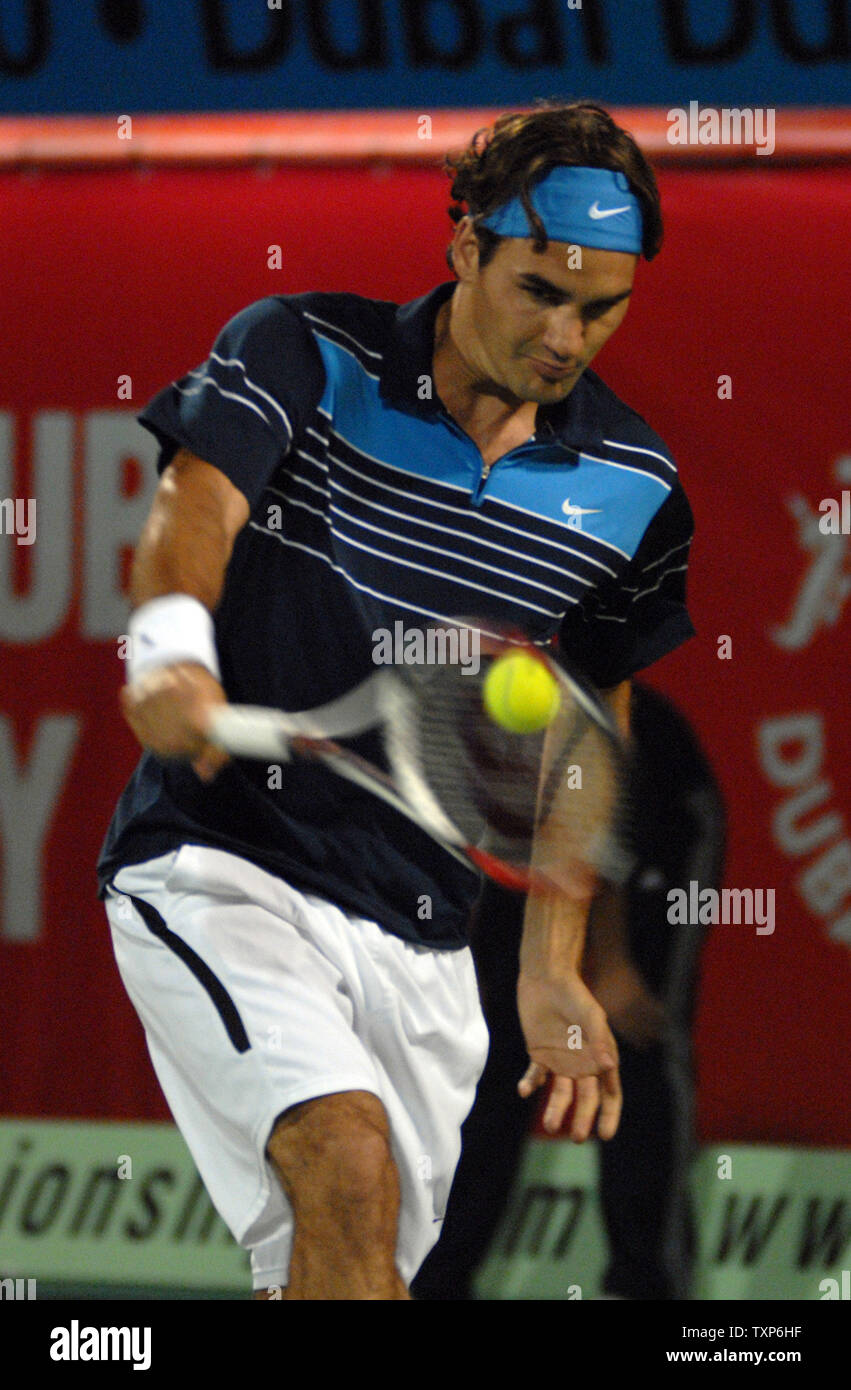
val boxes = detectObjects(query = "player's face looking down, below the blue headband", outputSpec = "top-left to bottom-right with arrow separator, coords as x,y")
453,224 -> 638,404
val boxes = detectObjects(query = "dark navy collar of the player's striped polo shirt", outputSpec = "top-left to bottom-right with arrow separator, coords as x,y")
378,279 -> 603,455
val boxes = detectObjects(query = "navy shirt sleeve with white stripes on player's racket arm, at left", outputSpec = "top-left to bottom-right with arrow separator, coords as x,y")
139,297 -> 324,506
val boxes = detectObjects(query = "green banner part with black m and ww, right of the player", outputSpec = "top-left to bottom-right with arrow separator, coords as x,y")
477,1138 -> 851,1300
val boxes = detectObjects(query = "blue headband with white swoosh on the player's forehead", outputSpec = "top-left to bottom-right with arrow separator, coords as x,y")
481,164 -> 642,254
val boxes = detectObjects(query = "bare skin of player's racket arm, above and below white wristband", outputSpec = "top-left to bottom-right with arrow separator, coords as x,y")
121,449 -> 250,781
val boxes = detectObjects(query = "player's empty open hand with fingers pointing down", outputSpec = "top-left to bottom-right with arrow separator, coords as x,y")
517,970 -> 622,1144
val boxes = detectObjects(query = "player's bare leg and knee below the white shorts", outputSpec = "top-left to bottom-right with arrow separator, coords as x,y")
261,1091 -> 409,1300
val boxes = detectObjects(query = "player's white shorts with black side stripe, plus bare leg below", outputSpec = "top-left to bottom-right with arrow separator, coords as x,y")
107,847 -> 487,1298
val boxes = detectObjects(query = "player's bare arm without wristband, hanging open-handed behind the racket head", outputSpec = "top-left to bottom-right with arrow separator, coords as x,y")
517,681 -> 630,1143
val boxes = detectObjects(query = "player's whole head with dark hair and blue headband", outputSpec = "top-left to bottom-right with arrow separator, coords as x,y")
446,101 -> 662,404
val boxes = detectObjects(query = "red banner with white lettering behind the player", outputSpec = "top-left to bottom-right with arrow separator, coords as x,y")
0,159 -> 851,1144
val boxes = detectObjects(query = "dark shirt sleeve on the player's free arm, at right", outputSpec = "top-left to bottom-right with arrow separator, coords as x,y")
559,481 -> 694,689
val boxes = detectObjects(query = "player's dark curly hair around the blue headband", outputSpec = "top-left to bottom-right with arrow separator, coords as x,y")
444,100 -> 662,270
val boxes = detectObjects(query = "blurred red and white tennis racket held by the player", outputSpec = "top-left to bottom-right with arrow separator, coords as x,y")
209,621 -> 631,897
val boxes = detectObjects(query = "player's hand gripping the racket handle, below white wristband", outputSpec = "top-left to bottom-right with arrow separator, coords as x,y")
121,662 -> 228,781
